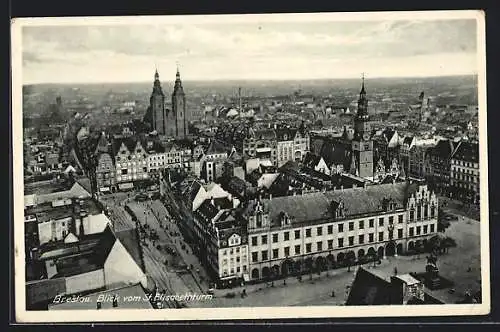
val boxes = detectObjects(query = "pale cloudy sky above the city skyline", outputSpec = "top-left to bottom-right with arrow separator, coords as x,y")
22,14 -> 478,84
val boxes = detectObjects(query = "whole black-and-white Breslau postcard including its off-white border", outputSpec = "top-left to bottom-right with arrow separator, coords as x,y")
11,10 -> 490,322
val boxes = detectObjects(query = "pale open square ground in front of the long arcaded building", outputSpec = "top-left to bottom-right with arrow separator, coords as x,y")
188,217 -> 481,307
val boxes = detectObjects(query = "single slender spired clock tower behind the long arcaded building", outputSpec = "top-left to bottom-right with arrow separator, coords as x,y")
351,76 -> 373,180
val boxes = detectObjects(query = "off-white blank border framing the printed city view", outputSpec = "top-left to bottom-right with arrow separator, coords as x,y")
11,10 -> 491,323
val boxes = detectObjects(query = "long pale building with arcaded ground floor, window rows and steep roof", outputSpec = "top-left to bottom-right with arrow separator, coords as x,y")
243,182 -> 437,280
